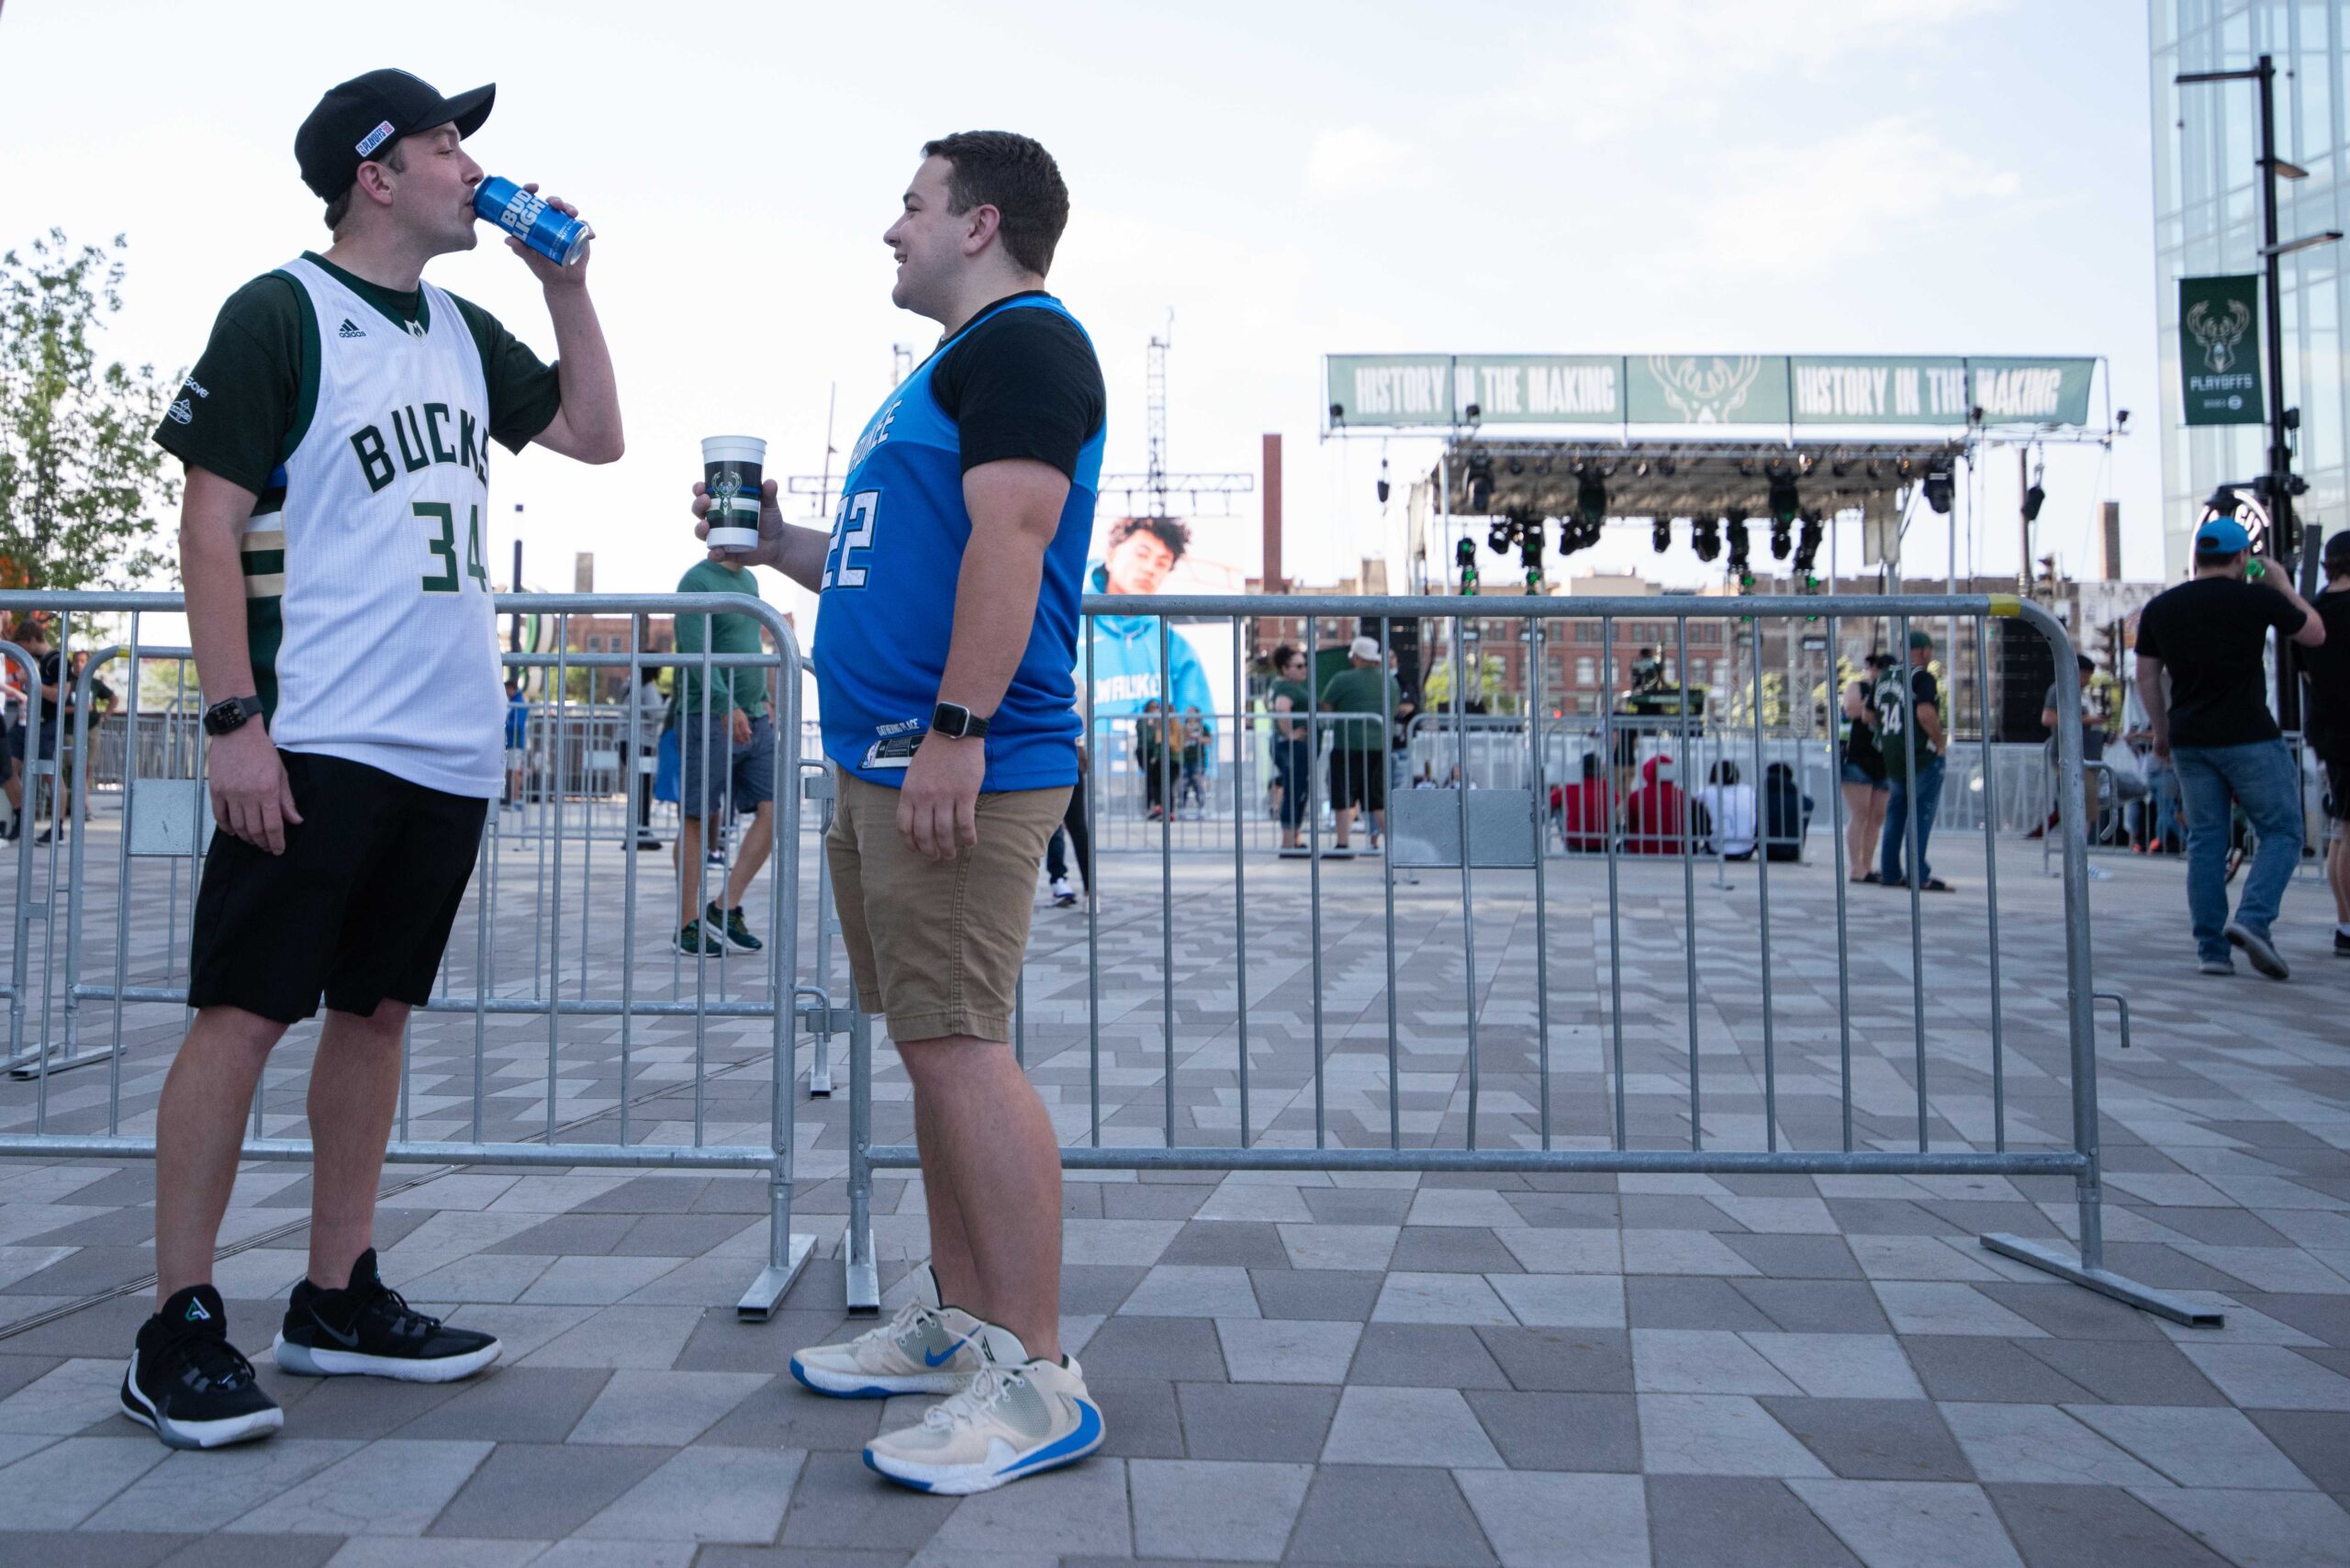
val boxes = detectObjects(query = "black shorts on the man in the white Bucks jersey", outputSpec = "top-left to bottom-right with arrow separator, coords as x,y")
188,752 -> 488,1023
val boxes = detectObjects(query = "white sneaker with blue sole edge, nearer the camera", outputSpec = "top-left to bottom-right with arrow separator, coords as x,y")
865,1324 -> 1102,1497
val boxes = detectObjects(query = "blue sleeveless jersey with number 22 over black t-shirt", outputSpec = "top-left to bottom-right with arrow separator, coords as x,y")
815,294 -> 1104,792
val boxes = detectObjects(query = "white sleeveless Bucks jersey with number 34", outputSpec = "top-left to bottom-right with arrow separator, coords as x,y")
240,259 -> 505,797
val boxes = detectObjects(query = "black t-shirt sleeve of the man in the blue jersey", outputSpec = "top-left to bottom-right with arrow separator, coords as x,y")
931,308 -> 1109,479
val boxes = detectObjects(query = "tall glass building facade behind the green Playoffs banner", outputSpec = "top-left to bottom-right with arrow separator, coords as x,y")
2148,0 -> 2350,580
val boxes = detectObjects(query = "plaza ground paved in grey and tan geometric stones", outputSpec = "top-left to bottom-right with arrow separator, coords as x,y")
0,823 -> 2350,1568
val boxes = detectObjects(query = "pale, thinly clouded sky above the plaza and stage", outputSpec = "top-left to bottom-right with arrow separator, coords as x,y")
0,0 -> 2160,625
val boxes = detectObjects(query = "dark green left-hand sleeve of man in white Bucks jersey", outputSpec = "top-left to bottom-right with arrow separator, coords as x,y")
155,273 -> 318,494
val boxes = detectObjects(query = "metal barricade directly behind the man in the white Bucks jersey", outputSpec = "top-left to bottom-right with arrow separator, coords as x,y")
0,592 -> 813,1319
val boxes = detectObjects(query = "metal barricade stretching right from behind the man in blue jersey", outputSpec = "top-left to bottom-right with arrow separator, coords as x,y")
846,595 -> 2219,1324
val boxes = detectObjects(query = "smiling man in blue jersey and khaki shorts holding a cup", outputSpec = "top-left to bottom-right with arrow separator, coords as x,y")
696,131 -> 1107,1495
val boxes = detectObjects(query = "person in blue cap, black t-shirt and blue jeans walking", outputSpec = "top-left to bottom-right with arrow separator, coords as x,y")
2139,517 -> 2326,980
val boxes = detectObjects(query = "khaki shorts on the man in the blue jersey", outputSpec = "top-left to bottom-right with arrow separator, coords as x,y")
825,768 -> 1069,1041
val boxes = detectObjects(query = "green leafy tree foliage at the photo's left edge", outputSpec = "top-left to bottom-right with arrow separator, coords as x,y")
0,228 -> 179,590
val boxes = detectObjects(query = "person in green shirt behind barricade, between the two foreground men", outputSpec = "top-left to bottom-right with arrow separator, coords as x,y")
677,559 -> 776,955
